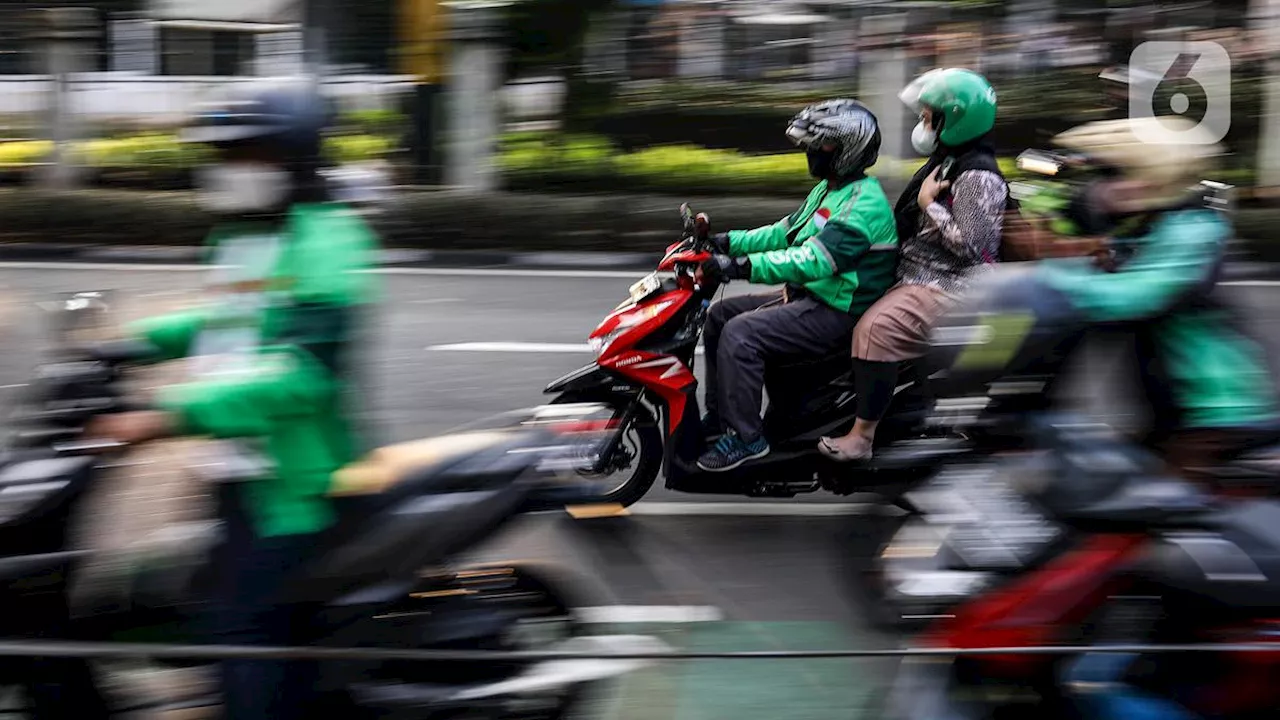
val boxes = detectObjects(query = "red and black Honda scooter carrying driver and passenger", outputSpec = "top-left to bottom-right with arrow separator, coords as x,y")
544,205 -> 966,505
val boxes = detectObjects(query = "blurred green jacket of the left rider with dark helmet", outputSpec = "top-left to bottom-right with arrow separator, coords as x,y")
132,204 -> 378,536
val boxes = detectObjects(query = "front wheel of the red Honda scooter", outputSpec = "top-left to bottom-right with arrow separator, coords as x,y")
552,393 -> 663,507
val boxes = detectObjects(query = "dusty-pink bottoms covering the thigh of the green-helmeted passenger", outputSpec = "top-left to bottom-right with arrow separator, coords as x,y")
854,284 -> 955,363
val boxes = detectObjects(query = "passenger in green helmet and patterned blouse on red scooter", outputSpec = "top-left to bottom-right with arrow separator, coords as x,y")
818,68 -> 1009,461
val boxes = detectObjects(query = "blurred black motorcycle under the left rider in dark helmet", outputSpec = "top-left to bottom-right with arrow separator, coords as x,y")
0,288 -> 664,719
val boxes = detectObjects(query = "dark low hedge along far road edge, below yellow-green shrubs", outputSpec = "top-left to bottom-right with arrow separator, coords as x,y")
0,183 -> 1280,259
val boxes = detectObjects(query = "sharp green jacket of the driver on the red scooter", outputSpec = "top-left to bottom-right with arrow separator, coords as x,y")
728,178 -> 897,315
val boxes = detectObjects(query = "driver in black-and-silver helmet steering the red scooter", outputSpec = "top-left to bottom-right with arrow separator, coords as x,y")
698,99 -> 897,471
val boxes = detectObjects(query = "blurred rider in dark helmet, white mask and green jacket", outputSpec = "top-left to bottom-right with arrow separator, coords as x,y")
90,82 -> 376,720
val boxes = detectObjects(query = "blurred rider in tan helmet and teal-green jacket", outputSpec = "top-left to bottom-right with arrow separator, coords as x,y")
1038,118 -> 1280,486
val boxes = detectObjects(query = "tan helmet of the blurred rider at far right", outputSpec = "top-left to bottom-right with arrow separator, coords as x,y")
1053,118 -> 1222,208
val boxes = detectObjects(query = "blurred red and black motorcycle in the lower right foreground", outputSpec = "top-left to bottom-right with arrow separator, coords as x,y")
878,415 -> 1280,720
